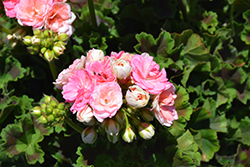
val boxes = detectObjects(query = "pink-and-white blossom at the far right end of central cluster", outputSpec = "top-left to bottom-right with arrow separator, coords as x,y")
152,83 -> 178,126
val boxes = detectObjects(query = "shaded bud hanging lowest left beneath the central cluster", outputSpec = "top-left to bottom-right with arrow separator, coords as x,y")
82,126 -> 97,144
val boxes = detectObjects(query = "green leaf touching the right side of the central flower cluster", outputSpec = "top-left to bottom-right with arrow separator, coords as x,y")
175,86 -> 193,120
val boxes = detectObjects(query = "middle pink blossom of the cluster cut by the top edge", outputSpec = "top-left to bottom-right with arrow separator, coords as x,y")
15,0 -> 53,29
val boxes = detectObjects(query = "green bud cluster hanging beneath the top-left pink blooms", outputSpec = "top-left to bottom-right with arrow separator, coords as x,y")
23,29 -> 68,62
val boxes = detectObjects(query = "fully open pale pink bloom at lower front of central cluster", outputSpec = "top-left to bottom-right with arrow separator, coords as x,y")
90,82 -> 123,122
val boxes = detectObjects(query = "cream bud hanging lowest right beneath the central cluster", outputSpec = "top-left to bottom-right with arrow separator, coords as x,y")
138,122 -> 155,140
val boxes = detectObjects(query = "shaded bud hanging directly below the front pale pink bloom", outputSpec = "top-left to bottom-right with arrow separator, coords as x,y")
104,119 -> 120,136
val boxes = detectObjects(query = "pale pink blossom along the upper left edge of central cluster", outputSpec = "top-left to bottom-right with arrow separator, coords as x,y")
53,56 -> 86,89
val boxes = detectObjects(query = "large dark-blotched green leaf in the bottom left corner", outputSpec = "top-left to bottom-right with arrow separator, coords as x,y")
1,116 -> 53,164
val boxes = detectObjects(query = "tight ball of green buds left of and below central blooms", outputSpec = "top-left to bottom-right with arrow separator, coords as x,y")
31,95 -> 65,126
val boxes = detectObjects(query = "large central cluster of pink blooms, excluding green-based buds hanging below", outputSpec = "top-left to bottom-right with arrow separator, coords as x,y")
54,49 -> 178,126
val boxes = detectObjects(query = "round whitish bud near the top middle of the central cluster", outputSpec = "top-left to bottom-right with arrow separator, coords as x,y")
112,59 -> 132,79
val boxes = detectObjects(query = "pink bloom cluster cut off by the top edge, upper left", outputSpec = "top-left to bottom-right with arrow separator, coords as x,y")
3,0 -> 76,36
